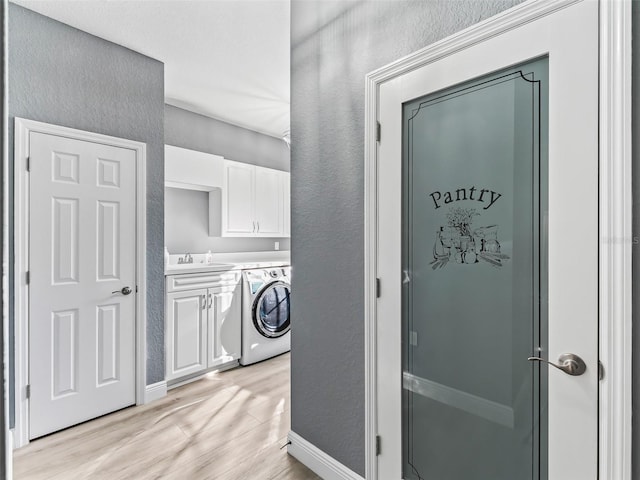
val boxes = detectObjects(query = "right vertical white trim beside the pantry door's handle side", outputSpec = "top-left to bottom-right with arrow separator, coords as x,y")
599,0 -> 634,480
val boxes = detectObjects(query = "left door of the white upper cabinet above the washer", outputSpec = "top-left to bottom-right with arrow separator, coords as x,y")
222,160 -> 257,237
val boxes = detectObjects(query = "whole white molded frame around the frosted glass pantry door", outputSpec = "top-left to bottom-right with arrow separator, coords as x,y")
364,0 -> 633,480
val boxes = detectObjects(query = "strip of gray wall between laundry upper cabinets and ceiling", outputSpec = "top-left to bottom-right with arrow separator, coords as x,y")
164,105 -> 290,172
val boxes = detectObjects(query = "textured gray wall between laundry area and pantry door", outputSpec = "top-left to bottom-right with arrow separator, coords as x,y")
291,0 -> 520,475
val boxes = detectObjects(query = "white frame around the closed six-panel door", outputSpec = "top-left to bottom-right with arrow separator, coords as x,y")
13,118 -> 147,448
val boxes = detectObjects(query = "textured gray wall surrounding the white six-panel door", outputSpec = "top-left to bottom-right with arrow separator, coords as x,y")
8,4 -> 164,424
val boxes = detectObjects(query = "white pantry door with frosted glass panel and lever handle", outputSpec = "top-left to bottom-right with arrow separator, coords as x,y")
375,1 -> 598,480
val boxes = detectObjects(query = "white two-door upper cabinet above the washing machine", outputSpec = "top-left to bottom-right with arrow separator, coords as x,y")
222,159 -> 288,237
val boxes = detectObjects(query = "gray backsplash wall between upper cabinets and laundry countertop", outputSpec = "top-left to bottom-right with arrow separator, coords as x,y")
164,188 -> 291,254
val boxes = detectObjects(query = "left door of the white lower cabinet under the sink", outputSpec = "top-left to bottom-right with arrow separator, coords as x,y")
165,289 -> 208,380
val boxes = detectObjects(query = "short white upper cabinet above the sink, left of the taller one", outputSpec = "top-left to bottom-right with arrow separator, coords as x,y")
164,145 -> 224,192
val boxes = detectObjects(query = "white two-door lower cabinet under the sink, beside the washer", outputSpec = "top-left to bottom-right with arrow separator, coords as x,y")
165,272 -> 241,383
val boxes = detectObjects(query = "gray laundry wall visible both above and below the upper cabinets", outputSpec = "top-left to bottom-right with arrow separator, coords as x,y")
164,105 -> 290,253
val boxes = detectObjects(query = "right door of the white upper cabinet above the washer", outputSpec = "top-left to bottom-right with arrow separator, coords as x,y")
255,167 -> 283,237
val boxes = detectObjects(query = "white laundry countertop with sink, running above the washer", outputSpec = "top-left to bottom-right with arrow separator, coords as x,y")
164,251 -> 291,275
